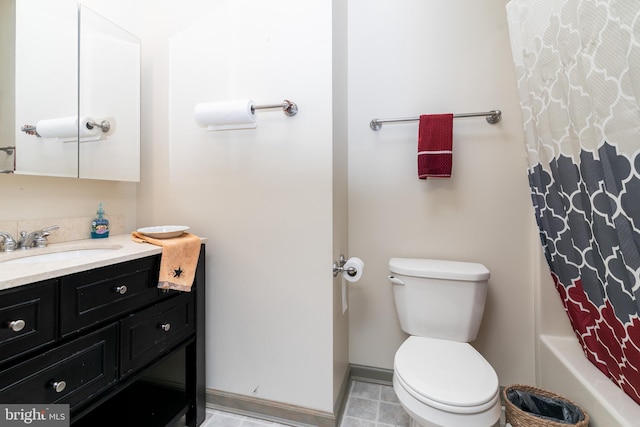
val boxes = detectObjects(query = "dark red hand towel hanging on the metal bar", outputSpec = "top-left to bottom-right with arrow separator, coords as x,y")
418,114 -> 453,179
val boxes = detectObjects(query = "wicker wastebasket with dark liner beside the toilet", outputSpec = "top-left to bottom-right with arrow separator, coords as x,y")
502,384 -> 589,427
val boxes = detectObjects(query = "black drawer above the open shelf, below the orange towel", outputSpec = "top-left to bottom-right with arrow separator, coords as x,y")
120,293 -> 195,375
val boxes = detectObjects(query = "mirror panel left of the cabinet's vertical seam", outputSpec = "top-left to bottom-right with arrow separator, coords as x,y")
13,0 -> 78,177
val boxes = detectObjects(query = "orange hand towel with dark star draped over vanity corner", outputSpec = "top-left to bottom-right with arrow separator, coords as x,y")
131,231 -> 201,292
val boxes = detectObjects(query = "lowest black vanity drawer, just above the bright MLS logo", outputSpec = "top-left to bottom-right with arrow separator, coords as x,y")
0,324 -> 118,408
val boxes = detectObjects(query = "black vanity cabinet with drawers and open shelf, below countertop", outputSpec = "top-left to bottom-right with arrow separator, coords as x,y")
0,245 -> 205,427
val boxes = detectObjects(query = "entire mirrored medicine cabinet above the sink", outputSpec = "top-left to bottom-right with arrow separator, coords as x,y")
0,0 -> 140,181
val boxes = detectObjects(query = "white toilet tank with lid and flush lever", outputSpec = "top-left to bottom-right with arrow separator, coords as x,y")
389,258 -> 490,342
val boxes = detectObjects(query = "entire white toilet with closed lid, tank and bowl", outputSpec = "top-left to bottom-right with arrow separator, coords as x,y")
389,258 -> 501,427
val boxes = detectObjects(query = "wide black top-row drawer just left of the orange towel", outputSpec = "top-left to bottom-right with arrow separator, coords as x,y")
60,257 -> 159,336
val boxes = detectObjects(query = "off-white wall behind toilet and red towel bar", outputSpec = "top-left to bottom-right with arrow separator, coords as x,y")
349,0 -> 535,385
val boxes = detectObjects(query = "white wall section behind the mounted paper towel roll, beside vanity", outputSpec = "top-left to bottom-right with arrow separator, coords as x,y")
139,0 -> 346,412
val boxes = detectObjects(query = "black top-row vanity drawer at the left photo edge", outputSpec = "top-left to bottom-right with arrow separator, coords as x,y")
0,280 -> 57,362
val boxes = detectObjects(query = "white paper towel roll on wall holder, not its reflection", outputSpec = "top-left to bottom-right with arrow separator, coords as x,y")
193,99 -> 256,130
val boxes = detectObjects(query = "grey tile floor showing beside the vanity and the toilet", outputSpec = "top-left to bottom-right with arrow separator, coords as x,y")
202,381 -> 409,427
